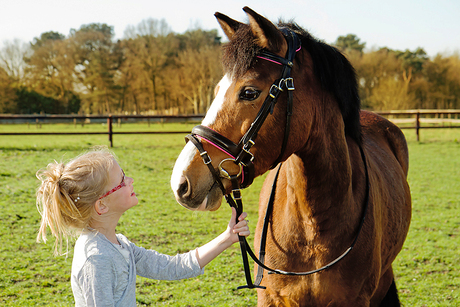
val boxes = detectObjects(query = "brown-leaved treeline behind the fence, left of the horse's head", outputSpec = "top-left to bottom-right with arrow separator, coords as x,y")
0,19 -> 222,114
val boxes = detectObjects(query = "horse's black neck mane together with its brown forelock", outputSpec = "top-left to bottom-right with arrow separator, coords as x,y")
222,22 -> 361,143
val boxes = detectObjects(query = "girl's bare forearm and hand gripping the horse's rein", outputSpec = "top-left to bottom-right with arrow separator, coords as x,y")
196,208 -> 250,268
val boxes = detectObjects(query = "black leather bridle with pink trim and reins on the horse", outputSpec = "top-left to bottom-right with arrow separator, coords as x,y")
186,28 -> 369,289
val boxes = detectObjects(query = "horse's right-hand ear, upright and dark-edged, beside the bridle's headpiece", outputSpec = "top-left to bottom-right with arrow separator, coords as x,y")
243,6 -> 287,56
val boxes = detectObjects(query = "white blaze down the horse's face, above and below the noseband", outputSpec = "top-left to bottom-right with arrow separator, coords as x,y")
171,75 -> 231,210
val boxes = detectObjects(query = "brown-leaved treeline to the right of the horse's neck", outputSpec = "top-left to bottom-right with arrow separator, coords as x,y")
335,34 -> 460,110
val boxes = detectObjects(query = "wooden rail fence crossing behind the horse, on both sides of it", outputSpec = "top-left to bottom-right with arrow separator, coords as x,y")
0,110 -> 460,147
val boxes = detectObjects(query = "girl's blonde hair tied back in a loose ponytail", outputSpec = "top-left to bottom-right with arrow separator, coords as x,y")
36,148 -> 115,255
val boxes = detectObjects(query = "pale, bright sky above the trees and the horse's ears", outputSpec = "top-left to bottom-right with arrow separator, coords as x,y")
0,0 -> 460,57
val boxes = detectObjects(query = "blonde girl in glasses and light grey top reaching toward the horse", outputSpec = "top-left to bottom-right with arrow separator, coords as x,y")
37,149 -> 249,306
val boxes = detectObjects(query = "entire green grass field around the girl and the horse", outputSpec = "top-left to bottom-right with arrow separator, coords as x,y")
0,124 -> 460,306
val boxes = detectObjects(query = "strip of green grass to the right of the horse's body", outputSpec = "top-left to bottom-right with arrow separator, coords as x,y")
395,129 -> 460,306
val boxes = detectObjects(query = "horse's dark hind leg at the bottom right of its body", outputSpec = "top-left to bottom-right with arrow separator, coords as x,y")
370,267 -> 401,307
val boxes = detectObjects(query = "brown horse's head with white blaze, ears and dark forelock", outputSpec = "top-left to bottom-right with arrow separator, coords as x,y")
171,7 -> 362,210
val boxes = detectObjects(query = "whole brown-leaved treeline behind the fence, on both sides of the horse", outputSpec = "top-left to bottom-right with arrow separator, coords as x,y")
0,19 -> 460,114
